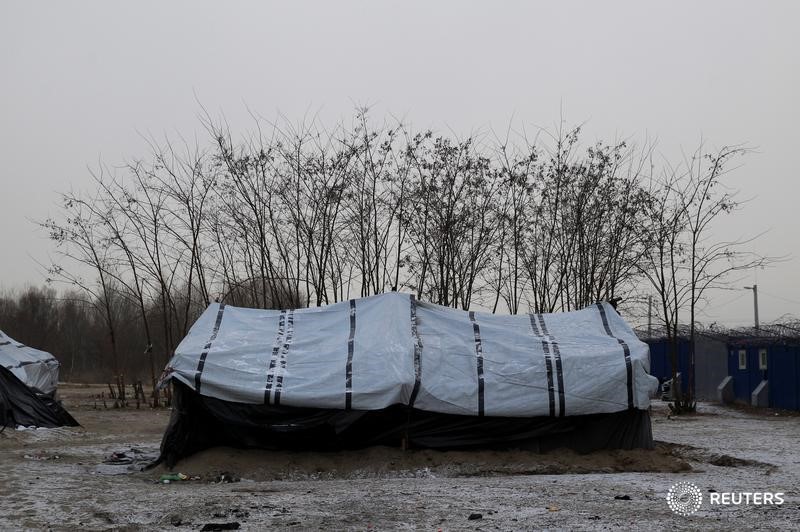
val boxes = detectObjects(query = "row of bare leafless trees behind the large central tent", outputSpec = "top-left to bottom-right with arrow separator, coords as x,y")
3,109 -> 763,408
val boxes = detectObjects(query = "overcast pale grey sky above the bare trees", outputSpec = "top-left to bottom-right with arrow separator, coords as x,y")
0,0 -> 800,325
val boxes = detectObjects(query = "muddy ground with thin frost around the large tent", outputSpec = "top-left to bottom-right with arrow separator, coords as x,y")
0,385 -> 800,531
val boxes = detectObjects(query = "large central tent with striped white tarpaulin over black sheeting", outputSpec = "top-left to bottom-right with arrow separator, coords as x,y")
155,292 -> 658,466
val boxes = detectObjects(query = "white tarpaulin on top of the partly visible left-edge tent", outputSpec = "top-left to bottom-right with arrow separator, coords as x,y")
0,331 -> 59,394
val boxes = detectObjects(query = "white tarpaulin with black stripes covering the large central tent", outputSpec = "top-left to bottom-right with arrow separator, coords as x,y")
165,293 -> 658,417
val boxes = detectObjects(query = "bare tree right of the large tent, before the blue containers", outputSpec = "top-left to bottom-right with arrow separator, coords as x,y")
643,144 -> 773,413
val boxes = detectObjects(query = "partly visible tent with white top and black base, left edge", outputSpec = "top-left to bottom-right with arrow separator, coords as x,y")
0,331 -> 78,427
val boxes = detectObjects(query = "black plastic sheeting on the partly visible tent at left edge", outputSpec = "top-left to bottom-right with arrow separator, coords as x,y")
0,366 -> 79,428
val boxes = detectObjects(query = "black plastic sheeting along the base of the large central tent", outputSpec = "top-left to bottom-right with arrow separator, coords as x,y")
158,381 -> 653,467
